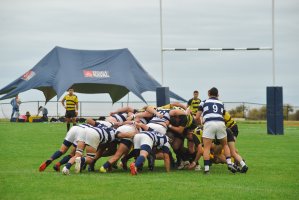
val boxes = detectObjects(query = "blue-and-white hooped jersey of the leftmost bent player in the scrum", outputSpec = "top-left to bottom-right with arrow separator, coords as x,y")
79,124 -> 116,144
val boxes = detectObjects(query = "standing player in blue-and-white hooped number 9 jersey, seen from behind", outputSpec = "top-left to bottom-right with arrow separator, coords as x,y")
196,87 -> 237,174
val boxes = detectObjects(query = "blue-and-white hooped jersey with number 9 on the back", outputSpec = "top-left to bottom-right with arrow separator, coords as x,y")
198,97 -> 224,123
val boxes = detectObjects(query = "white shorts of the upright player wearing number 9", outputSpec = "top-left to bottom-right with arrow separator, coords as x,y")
202,121 -> 227,139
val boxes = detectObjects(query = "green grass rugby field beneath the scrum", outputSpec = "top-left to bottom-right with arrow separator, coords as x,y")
0,122 -> 299,200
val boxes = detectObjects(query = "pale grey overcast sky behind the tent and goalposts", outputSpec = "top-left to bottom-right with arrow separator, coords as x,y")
0,0 -> 299,106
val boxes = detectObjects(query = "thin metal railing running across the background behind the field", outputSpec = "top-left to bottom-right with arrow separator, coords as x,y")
0,101 -> 299,120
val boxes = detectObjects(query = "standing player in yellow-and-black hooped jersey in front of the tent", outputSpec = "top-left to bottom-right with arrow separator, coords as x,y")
61,88 -> 78,131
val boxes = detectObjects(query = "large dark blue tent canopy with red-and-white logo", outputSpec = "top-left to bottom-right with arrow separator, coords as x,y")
0,47 -> 185,103
